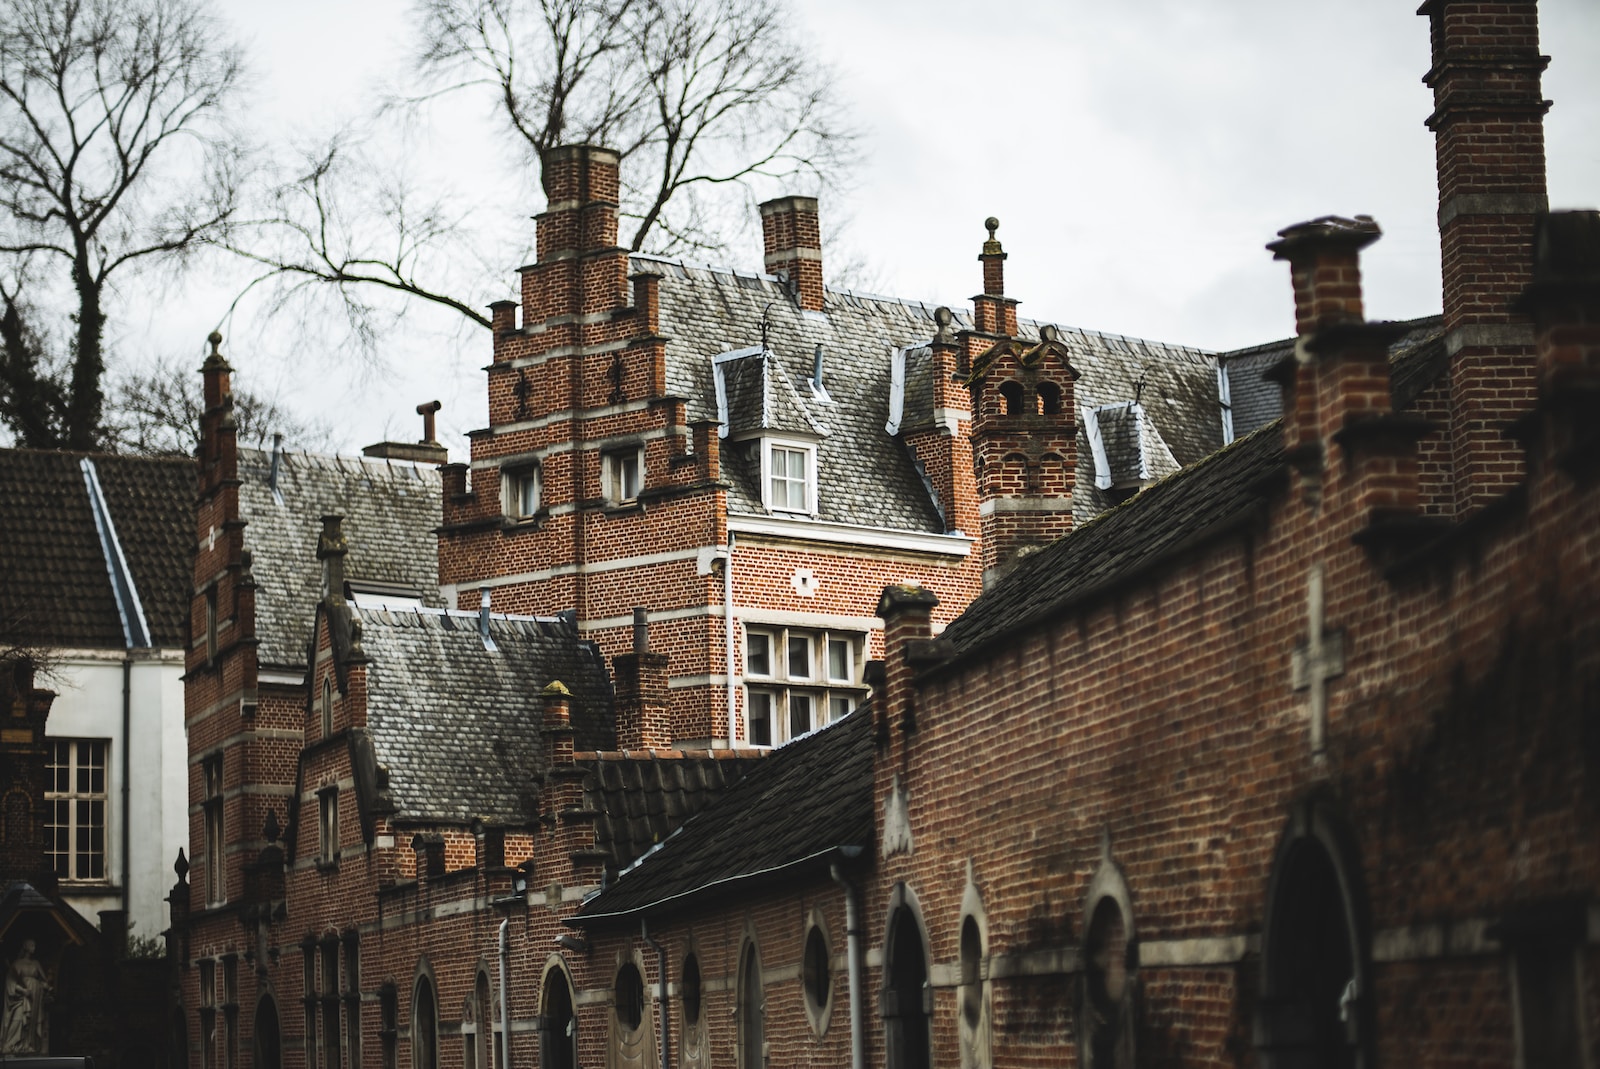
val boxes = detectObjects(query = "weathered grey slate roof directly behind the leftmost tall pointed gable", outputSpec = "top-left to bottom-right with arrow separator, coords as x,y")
238,450 -> 443,667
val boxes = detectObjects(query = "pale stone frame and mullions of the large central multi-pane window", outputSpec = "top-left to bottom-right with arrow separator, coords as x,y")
739,623 -> 867,747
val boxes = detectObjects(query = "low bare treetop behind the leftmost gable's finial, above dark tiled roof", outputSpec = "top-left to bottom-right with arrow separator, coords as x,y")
106,358 -> 333,456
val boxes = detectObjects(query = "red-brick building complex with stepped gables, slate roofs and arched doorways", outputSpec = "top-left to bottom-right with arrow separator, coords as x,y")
174,0 -> 1600,1069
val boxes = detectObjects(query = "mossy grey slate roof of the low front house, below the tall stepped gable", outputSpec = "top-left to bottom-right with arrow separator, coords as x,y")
352,604 -> 616,824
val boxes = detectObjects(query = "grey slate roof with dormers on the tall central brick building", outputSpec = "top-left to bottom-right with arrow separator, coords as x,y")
632,254 -> 1222,535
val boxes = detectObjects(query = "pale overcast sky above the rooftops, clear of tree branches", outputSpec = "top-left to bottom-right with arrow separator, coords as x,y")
156,0 -> 1600,459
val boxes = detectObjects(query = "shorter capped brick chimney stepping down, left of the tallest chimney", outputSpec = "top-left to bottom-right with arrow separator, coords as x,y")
1267,216 -> 1432,555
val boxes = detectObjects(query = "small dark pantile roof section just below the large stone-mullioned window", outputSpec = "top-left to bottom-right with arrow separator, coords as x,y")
578,751 -> 766,874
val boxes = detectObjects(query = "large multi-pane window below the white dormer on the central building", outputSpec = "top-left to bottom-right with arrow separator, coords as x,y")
744,626 -> 866,746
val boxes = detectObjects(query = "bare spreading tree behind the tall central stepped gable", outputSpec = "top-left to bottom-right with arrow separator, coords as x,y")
222,0 -> 854,349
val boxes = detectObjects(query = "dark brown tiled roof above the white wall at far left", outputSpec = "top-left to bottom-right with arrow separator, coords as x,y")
0,450 -> 195,650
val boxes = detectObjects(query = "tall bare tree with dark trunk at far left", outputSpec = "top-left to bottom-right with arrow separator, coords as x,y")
0,0 -> 240,450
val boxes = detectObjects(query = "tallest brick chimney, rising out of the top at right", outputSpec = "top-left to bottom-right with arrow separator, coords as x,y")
1418,0 -> 1549,515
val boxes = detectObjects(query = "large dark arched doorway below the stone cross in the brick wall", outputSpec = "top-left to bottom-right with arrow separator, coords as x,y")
1258,807 -> 1371,1069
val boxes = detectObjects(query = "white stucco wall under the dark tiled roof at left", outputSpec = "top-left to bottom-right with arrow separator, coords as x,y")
40,650 -> 189,938
